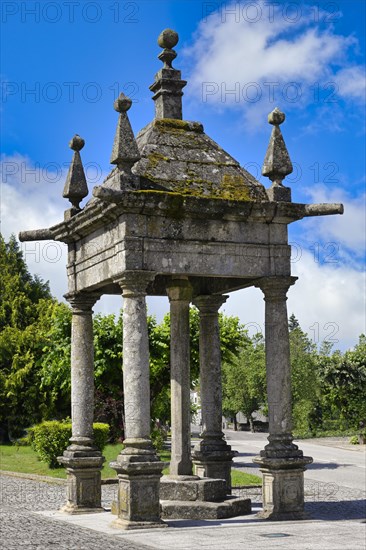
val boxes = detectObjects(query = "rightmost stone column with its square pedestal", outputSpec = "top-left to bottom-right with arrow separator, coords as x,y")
253,277 -> 312,520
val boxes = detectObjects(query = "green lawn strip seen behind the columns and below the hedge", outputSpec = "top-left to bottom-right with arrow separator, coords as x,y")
0,443 -> 262,487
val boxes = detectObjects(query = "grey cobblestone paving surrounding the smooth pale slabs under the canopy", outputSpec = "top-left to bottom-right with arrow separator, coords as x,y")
0,475 -> 366,550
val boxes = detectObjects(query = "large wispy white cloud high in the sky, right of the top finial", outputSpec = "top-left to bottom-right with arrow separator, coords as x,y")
183,0 -> 365,122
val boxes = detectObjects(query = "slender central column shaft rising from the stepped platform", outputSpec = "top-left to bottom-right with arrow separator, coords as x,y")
167,279 -> 192,476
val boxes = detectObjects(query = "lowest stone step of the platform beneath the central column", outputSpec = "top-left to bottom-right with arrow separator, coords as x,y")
160,497 -> 252,519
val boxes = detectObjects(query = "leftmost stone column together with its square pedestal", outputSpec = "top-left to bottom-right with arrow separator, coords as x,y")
58,293 -> 104,514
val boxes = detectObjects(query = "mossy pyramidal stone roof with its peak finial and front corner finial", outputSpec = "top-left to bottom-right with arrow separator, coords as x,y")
96,29 -> 268,205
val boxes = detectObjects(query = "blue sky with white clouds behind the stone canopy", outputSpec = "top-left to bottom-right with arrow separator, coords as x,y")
1,0 -> 366,348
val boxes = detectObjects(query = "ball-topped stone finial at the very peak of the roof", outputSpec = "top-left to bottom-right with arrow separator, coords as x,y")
150,29 -> 187,120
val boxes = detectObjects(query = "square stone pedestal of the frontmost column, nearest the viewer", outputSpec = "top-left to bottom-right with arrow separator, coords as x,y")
110,441 -> 167,529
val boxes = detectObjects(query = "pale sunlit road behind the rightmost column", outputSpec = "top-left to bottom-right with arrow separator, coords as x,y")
225,430 -> 366,491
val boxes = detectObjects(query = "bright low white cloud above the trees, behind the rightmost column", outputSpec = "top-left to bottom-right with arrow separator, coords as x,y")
222,251 -> 366,350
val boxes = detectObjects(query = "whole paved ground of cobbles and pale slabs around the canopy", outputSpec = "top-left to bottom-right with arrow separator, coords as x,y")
0,436 -> 366,550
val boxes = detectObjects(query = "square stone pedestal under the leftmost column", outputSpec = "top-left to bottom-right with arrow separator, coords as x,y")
58,450 -> 104,514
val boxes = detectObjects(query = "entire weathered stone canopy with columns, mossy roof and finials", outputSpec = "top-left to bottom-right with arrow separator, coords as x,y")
20,29 -> 343,528
